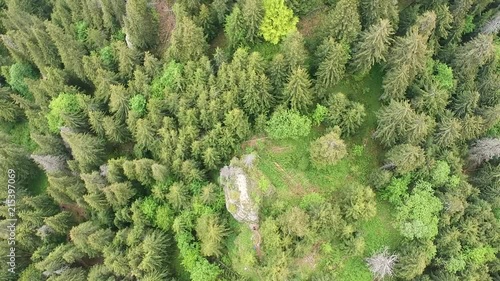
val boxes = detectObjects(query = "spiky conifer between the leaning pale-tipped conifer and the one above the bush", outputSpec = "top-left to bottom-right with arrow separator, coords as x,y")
316,37 -> 349,88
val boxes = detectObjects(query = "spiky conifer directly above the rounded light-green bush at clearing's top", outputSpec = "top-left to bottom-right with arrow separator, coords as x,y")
283,67 -> 314,112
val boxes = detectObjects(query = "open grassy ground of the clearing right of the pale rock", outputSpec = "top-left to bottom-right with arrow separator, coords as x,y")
234,65 -> 401,281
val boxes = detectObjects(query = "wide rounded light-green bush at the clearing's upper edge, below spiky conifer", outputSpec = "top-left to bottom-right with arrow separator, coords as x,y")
265,107 -> 311,139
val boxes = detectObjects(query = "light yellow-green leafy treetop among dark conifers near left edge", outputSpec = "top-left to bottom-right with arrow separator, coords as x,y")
47,93 -> 82,132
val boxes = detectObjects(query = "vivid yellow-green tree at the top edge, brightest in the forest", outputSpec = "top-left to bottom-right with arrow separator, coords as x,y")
260,0 -> 299,44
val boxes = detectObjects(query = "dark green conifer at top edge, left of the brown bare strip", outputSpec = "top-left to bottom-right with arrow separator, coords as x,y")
124,0 -> 158,50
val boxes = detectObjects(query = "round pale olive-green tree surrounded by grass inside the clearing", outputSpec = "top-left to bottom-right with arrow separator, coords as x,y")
310,132 -> 347,168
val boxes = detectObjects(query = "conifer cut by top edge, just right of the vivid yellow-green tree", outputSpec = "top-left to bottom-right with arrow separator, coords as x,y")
325,0 -> 361,45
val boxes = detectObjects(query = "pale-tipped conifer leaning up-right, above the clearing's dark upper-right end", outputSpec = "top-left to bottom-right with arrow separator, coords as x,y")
352,19 -> 394,76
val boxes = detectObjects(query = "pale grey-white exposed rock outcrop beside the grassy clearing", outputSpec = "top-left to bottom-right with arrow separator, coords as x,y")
220,155 -> 259,224
